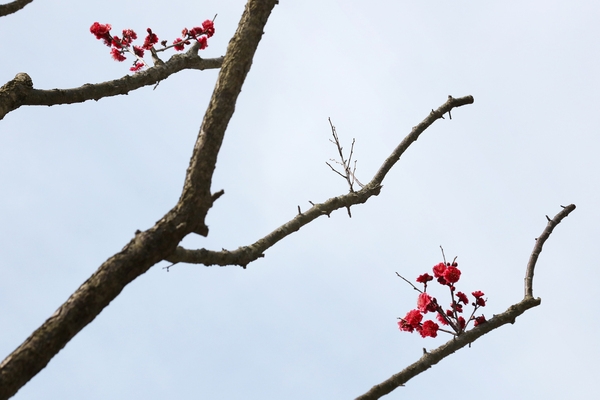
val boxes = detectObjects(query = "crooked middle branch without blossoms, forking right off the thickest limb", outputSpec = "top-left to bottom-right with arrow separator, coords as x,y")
166,96 -> 474,267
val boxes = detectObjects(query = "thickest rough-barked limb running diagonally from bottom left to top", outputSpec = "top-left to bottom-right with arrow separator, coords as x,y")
0,0 -> 277,400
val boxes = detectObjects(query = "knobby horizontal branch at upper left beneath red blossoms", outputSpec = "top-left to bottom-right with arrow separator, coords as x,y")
0,52 -> 223,119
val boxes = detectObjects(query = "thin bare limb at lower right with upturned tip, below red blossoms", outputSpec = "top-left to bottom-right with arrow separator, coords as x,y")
356,204 -> 575,400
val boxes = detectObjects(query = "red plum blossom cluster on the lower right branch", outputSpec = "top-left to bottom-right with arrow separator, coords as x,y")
398,261 -> 487,338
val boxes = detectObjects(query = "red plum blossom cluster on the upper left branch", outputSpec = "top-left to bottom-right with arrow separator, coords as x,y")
90,20 -> 215,72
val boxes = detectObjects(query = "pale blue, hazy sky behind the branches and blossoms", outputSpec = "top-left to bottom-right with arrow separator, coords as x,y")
0,0 -> 600,400
